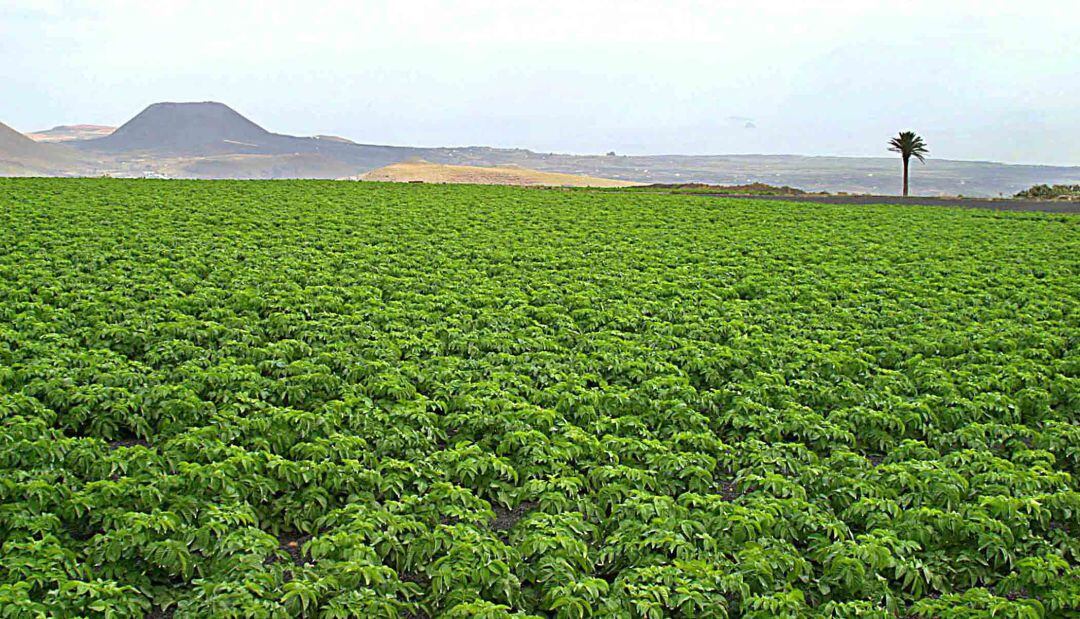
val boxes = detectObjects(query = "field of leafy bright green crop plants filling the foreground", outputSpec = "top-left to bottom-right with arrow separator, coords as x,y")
0,179 -> 1080,619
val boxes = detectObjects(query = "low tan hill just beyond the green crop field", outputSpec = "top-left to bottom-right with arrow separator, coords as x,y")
360,160 -> 635,187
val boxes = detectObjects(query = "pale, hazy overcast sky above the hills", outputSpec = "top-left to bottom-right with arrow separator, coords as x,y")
0,0 -> 1080,165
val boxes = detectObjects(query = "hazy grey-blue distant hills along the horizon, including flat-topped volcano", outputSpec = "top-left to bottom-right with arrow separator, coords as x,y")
0,102 -> 1080,197
